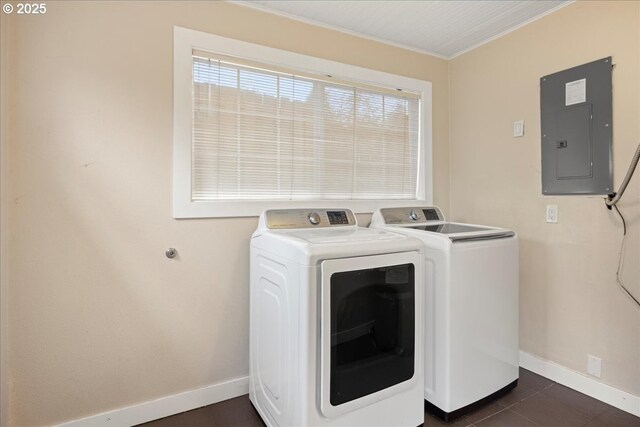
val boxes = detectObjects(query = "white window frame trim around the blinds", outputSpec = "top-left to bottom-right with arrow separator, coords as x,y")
173,26 -> 433,218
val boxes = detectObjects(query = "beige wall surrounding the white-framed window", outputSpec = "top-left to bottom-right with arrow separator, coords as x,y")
2,1 -> 449,426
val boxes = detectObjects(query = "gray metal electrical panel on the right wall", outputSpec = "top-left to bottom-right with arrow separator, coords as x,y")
540,57 -> 613,195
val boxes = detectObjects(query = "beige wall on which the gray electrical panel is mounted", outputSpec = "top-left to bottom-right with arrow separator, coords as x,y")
449,1 -> 640,395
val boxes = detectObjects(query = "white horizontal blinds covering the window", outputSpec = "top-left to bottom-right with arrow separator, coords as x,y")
191,52 -> 420,201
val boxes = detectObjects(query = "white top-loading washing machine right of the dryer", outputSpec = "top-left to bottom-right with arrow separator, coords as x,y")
371,207 -> 519,421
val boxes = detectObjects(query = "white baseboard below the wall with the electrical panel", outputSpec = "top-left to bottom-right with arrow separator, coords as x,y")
520,350 -> 640,417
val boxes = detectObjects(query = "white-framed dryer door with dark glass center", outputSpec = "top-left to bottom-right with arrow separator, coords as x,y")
319,252 -> 422,417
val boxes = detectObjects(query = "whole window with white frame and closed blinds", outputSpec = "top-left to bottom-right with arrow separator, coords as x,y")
174,27 -> 431,218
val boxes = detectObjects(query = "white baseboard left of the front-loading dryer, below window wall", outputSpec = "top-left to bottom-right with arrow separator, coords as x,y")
58,377 -> 249,427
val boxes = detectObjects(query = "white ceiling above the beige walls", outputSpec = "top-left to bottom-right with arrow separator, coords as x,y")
235,0 -> 572,59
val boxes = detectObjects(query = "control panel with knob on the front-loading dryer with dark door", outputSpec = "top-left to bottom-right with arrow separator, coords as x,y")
264,209 -> 358,229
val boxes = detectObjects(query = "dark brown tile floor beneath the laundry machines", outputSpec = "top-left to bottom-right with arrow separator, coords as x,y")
141,368 -> 640,427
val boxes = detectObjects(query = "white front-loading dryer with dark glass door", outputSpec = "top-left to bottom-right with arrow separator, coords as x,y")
249,209 -> 424,426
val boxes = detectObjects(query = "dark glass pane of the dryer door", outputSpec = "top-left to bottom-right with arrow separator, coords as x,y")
330,264 -> 415,406
